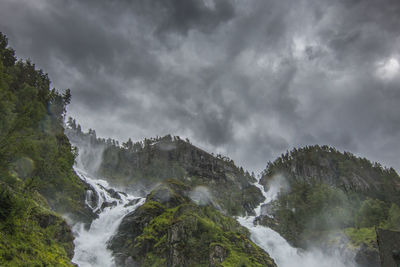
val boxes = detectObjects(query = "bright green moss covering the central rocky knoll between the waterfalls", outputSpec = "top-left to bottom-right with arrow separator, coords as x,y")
131,197 -> 275,266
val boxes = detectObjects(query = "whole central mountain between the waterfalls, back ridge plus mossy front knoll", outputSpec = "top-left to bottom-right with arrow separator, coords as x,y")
66,126 -> 275,266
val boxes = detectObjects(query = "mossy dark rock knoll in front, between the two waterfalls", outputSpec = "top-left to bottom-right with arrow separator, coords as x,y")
109,180 -> 276,266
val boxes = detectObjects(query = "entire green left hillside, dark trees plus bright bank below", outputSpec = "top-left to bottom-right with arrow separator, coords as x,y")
0,33 -> 85,266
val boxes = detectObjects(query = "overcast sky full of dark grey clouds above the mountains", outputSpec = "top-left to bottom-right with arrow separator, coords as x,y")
0,0 -> 400,171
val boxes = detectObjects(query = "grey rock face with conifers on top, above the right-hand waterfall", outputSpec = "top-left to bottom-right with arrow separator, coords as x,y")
260,145 -> 400,204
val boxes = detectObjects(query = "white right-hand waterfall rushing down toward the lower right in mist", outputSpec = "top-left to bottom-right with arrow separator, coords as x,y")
237,177 -> 356,267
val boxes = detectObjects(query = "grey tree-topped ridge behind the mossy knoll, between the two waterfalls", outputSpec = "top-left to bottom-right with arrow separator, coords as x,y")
66,126 -> 264,215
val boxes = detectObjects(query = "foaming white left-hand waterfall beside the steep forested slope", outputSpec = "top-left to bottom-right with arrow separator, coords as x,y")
72,168 -> 144,267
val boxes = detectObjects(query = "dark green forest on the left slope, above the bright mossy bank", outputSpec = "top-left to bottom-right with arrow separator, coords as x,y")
0,35 -> 87,222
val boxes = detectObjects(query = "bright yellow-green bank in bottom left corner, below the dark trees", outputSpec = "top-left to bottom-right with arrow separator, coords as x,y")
0,188 -> 74,266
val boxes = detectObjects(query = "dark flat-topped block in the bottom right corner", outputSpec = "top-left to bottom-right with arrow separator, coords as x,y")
376,228 -> 400,267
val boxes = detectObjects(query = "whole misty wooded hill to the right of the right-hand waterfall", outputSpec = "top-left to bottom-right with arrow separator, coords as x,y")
257,146 -> 400,266
